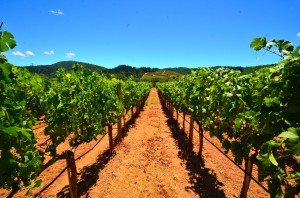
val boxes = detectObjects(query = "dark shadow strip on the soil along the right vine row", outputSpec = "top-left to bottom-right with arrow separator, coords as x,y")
161,96 -> 226,198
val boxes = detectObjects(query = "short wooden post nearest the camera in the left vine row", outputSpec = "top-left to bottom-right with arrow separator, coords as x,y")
66,151 -> 77,198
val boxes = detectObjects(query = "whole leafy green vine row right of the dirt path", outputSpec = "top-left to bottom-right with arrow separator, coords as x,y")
157,38 -> 300,197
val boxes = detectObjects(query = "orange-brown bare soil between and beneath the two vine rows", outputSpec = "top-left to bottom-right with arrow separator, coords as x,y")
0,88 -> 268,198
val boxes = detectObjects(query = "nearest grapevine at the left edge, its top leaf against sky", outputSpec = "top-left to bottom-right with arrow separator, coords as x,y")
0,27 -> 42,191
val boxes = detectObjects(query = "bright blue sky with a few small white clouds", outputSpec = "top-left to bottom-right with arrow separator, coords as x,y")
0,0 -> 300,68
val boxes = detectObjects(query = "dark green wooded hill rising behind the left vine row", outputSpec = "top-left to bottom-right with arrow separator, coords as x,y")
25,61 -> 106,77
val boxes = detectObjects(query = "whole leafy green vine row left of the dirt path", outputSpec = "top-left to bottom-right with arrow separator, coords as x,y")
0,63 -> 151,194
